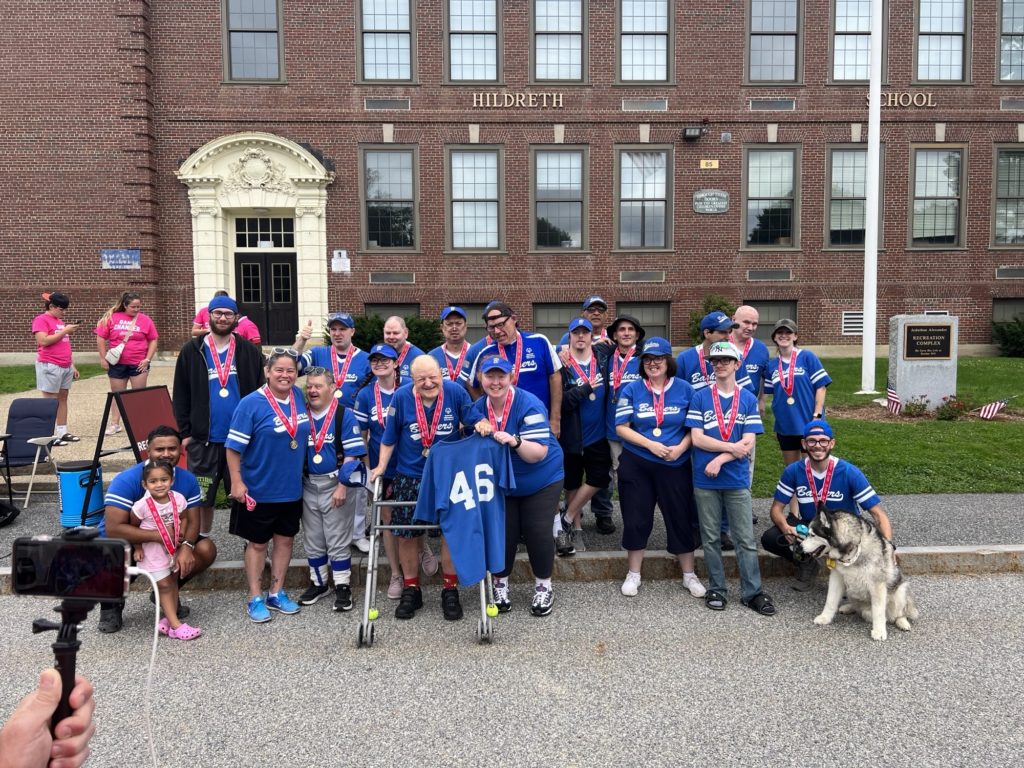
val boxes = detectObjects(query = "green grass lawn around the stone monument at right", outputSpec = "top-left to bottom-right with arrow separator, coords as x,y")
754,357 -> 1024,497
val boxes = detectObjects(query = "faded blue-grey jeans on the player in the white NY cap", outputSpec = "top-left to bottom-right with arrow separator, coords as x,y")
693,487 -> 761,600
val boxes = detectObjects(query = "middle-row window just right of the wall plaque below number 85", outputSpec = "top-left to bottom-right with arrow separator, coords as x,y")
745,148 -> 799,248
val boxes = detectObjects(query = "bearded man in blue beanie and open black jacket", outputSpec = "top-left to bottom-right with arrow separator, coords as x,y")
173,296 -> 263,538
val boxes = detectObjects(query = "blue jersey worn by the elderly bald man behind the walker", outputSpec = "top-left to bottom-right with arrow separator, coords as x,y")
382,381 -> 473,477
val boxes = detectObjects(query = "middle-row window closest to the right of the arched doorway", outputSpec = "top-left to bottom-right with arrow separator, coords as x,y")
362,150 -> 417,250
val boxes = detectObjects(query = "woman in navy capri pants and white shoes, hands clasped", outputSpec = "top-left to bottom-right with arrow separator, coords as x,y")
615,336 -> 705,597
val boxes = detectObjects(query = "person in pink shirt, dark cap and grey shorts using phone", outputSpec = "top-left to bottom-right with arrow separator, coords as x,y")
32,291 -> 81,445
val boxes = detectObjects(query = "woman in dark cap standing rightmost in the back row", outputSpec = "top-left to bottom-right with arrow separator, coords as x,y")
765,318 -> 831,499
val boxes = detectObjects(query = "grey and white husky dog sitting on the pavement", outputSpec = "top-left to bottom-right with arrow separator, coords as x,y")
801,504 -> 918,640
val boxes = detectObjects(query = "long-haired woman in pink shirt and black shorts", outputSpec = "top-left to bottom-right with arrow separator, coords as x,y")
96,291 -> 158,434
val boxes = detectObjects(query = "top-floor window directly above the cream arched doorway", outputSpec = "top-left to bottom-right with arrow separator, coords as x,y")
224,0 -> 283,80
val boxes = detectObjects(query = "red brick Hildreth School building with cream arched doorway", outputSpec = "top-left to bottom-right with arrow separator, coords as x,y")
0,0 -> 1024,351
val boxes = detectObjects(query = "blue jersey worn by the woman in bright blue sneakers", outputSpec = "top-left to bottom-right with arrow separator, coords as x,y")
224,387 -> 309,503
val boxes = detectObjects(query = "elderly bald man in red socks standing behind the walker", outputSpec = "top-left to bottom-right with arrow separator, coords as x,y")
370,354 -> 472,622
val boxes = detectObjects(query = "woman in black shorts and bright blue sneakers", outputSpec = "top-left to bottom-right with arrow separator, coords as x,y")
224,347 -> 309,624
